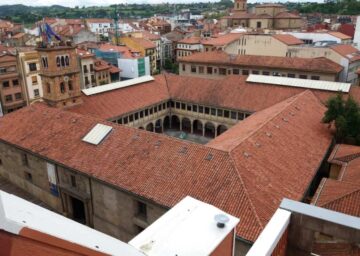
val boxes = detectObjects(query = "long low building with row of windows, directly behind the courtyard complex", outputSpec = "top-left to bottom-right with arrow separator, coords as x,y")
179,51 -> 343,81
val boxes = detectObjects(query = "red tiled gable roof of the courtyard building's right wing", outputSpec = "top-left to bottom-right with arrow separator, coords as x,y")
207,90 -> 332,223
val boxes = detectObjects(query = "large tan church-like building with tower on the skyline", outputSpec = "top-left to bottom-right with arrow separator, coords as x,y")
221,0 -> 303,30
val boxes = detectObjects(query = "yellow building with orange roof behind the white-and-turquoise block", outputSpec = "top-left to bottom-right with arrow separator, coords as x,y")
120,36 -> 158,74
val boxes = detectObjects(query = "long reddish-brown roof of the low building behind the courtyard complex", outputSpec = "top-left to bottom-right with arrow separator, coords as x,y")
179,51 -> 343,74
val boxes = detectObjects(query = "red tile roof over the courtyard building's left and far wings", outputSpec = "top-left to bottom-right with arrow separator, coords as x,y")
69,74 -> 360,119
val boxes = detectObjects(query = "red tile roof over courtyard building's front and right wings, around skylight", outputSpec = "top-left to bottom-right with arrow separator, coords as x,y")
0,90 -> 331,241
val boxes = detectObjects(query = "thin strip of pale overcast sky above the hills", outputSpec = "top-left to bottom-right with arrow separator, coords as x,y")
0,0 -> 323,7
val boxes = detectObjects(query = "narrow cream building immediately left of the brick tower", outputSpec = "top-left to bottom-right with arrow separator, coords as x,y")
17,49 -> 43,105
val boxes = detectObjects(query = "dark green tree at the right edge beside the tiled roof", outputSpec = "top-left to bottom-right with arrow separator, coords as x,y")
323,94 -> 360,145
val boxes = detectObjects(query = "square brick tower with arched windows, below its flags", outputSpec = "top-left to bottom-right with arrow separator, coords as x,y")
37,43 -> 82,108
